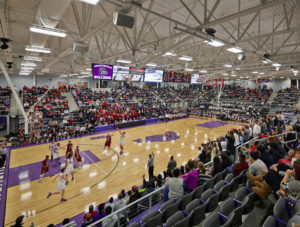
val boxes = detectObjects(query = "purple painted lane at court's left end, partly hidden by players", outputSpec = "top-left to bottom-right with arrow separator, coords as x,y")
8,151 -> 100,187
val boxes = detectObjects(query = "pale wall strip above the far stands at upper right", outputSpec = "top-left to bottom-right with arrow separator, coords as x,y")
240,79 -> 291,92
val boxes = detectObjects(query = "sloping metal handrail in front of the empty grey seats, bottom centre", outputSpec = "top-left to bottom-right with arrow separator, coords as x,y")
85,161 -> 212,227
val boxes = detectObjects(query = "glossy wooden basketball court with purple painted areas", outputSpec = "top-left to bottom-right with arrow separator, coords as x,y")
5,116 -> 242,226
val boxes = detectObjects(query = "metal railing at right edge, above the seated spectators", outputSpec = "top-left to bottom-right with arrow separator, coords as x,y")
235,131 -> 298,160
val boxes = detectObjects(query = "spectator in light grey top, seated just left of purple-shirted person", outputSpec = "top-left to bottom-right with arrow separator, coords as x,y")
164,169 -> 183,199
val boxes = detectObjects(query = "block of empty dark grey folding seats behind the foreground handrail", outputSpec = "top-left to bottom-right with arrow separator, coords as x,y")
129,170 -> 254,227
